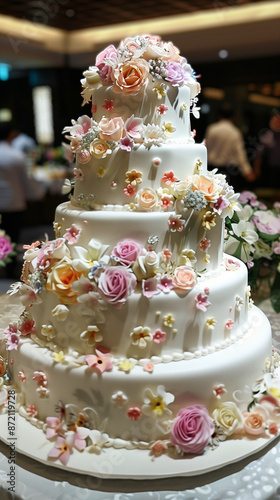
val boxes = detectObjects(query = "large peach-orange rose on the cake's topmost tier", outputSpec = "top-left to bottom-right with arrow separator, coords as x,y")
112,58 -> 150,95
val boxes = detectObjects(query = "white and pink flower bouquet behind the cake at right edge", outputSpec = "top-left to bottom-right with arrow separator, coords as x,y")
225,191 -> 280,312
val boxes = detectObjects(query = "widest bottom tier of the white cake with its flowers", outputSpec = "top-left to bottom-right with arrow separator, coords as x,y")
2,307 -> 279,465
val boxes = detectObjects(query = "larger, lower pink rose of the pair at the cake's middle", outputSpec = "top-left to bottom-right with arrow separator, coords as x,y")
98,266 -> 136,307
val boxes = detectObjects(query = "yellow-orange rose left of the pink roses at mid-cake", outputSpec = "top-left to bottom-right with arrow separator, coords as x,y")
46,257 -> 82,304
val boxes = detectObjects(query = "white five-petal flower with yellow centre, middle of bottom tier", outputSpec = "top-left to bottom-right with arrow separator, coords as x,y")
142,385 -> 175,420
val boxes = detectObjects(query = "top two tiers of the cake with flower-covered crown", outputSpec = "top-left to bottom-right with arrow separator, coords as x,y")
64,36 -> 203,211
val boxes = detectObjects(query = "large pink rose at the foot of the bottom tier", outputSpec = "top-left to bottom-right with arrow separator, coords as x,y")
170,405 -> 215,455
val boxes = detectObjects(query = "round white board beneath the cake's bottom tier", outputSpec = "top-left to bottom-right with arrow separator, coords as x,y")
0,414 -> 277,480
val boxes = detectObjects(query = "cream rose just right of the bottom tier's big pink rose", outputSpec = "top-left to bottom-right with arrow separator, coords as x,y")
212,401 -> 243,436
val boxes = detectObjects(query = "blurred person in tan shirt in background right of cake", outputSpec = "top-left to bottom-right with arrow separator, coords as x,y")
205,104 -> 255,192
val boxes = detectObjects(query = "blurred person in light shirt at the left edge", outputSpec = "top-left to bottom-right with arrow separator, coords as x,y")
0,122 -> 45,278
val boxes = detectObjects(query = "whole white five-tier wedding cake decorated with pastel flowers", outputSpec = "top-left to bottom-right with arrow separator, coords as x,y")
2,36 -> 279,475
